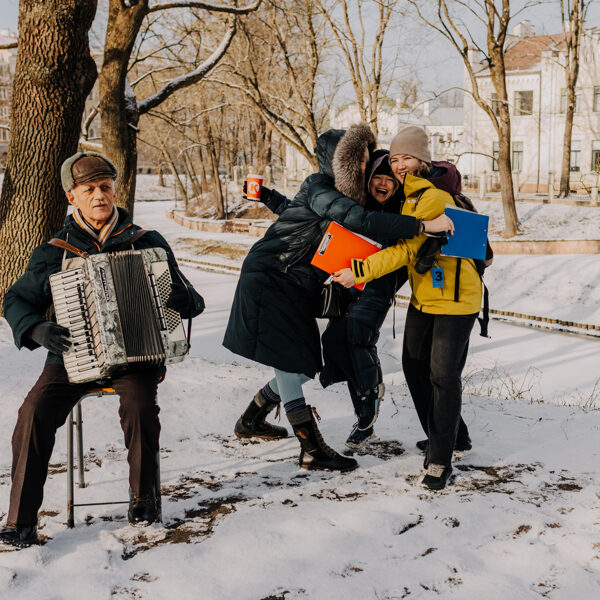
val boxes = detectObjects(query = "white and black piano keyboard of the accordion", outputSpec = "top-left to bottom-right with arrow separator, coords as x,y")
50,268 -> 103,381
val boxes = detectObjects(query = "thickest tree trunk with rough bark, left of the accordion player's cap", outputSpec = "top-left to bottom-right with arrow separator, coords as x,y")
0,0 -> 96,312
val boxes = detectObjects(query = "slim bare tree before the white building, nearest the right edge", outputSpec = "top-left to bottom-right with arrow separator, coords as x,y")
559,0 -> 591,197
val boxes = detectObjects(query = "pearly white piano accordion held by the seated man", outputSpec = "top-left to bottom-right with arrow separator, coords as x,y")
50,248 -> 189,383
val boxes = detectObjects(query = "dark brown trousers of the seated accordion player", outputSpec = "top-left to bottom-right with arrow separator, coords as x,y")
7,365 -> 160,525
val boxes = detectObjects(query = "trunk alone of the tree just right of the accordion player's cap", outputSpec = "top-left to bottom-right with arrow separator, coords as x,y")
98,0 -> 148,215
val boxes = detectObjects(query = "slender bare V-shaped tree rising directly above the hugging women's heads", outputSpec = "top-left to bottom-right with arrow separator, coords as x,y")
315,0 -> 399,136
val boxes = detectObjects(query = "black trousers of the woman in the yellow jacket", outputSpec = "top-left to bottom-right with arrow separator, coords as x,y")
402,304 -> 477,466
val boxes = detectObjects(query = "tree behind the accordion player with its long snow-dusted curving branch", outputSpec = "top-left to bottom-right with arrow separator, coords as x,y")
99,0 -> 261,212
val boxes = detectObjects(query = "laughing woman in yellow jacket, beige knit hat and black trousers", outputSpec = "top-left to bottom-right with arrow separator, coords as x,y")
334,125 -> 482,490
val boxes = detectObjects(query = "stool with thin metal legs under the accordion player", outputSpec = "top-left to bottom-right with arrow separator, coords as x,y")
67,387 -> 162,527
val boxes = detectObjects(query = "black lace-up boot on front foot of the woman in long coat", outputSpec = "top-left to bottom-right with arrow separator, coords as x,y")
288,406 -> 358,471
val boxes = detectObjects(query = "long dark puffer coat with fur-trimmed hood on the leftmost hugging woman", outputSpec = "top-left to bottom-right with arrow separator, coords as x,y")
223,125 -> 419,377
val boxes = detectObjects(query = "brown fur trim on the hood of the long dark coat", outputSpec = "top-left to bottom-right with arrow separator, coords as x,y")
333,123 -> 376,206
